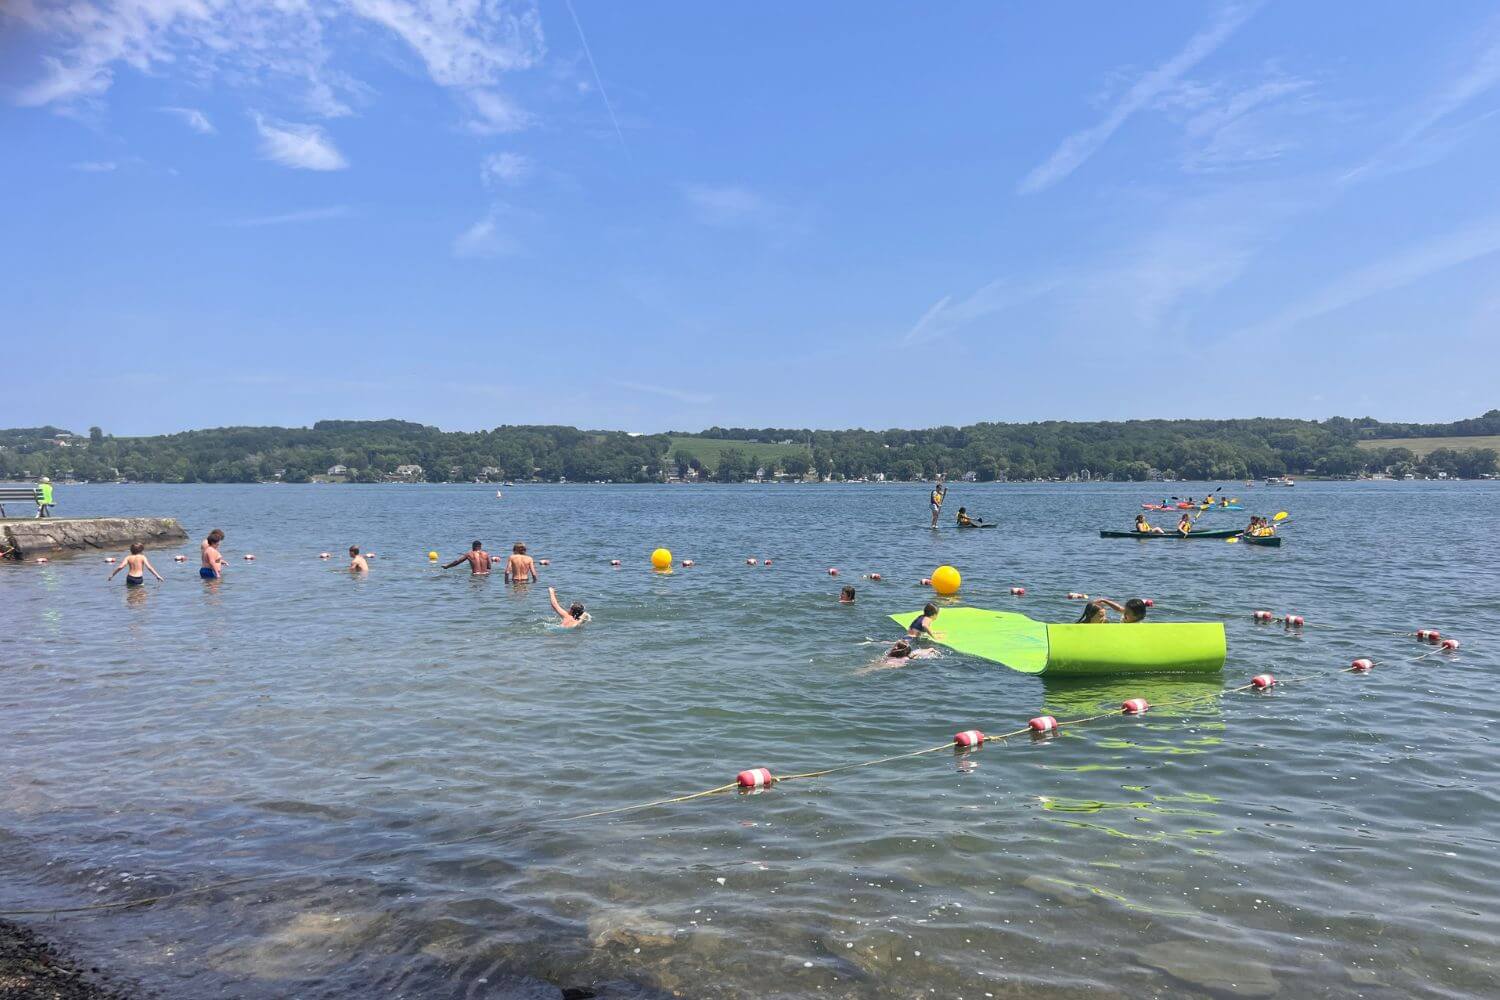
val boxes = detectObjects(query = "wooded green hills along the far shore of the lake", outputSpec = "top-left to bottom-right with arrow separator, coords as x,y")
0,409 -> 1500,483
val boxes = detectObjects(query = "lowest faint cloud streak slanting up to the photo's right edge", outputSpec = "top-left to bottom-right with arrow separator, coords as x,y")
1247,216 -> 1500,336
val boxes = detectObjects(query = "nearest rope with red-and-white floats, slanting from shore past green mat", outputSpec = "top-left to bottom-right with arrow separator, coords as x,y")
0,620 -> 1458,916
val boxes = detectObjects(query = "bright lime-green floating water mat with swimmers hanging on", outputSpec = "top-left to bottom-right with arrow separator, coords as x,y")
891,607 -> 1227,676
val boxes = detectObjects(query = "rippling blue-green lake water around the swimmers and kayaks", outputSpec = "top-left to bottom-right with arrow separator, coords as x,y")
0,483 -> 1500,997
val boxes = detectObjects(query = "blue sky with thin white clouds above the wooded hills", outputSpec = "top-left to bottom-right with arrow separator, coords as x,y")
0,0 -> 1500,433
